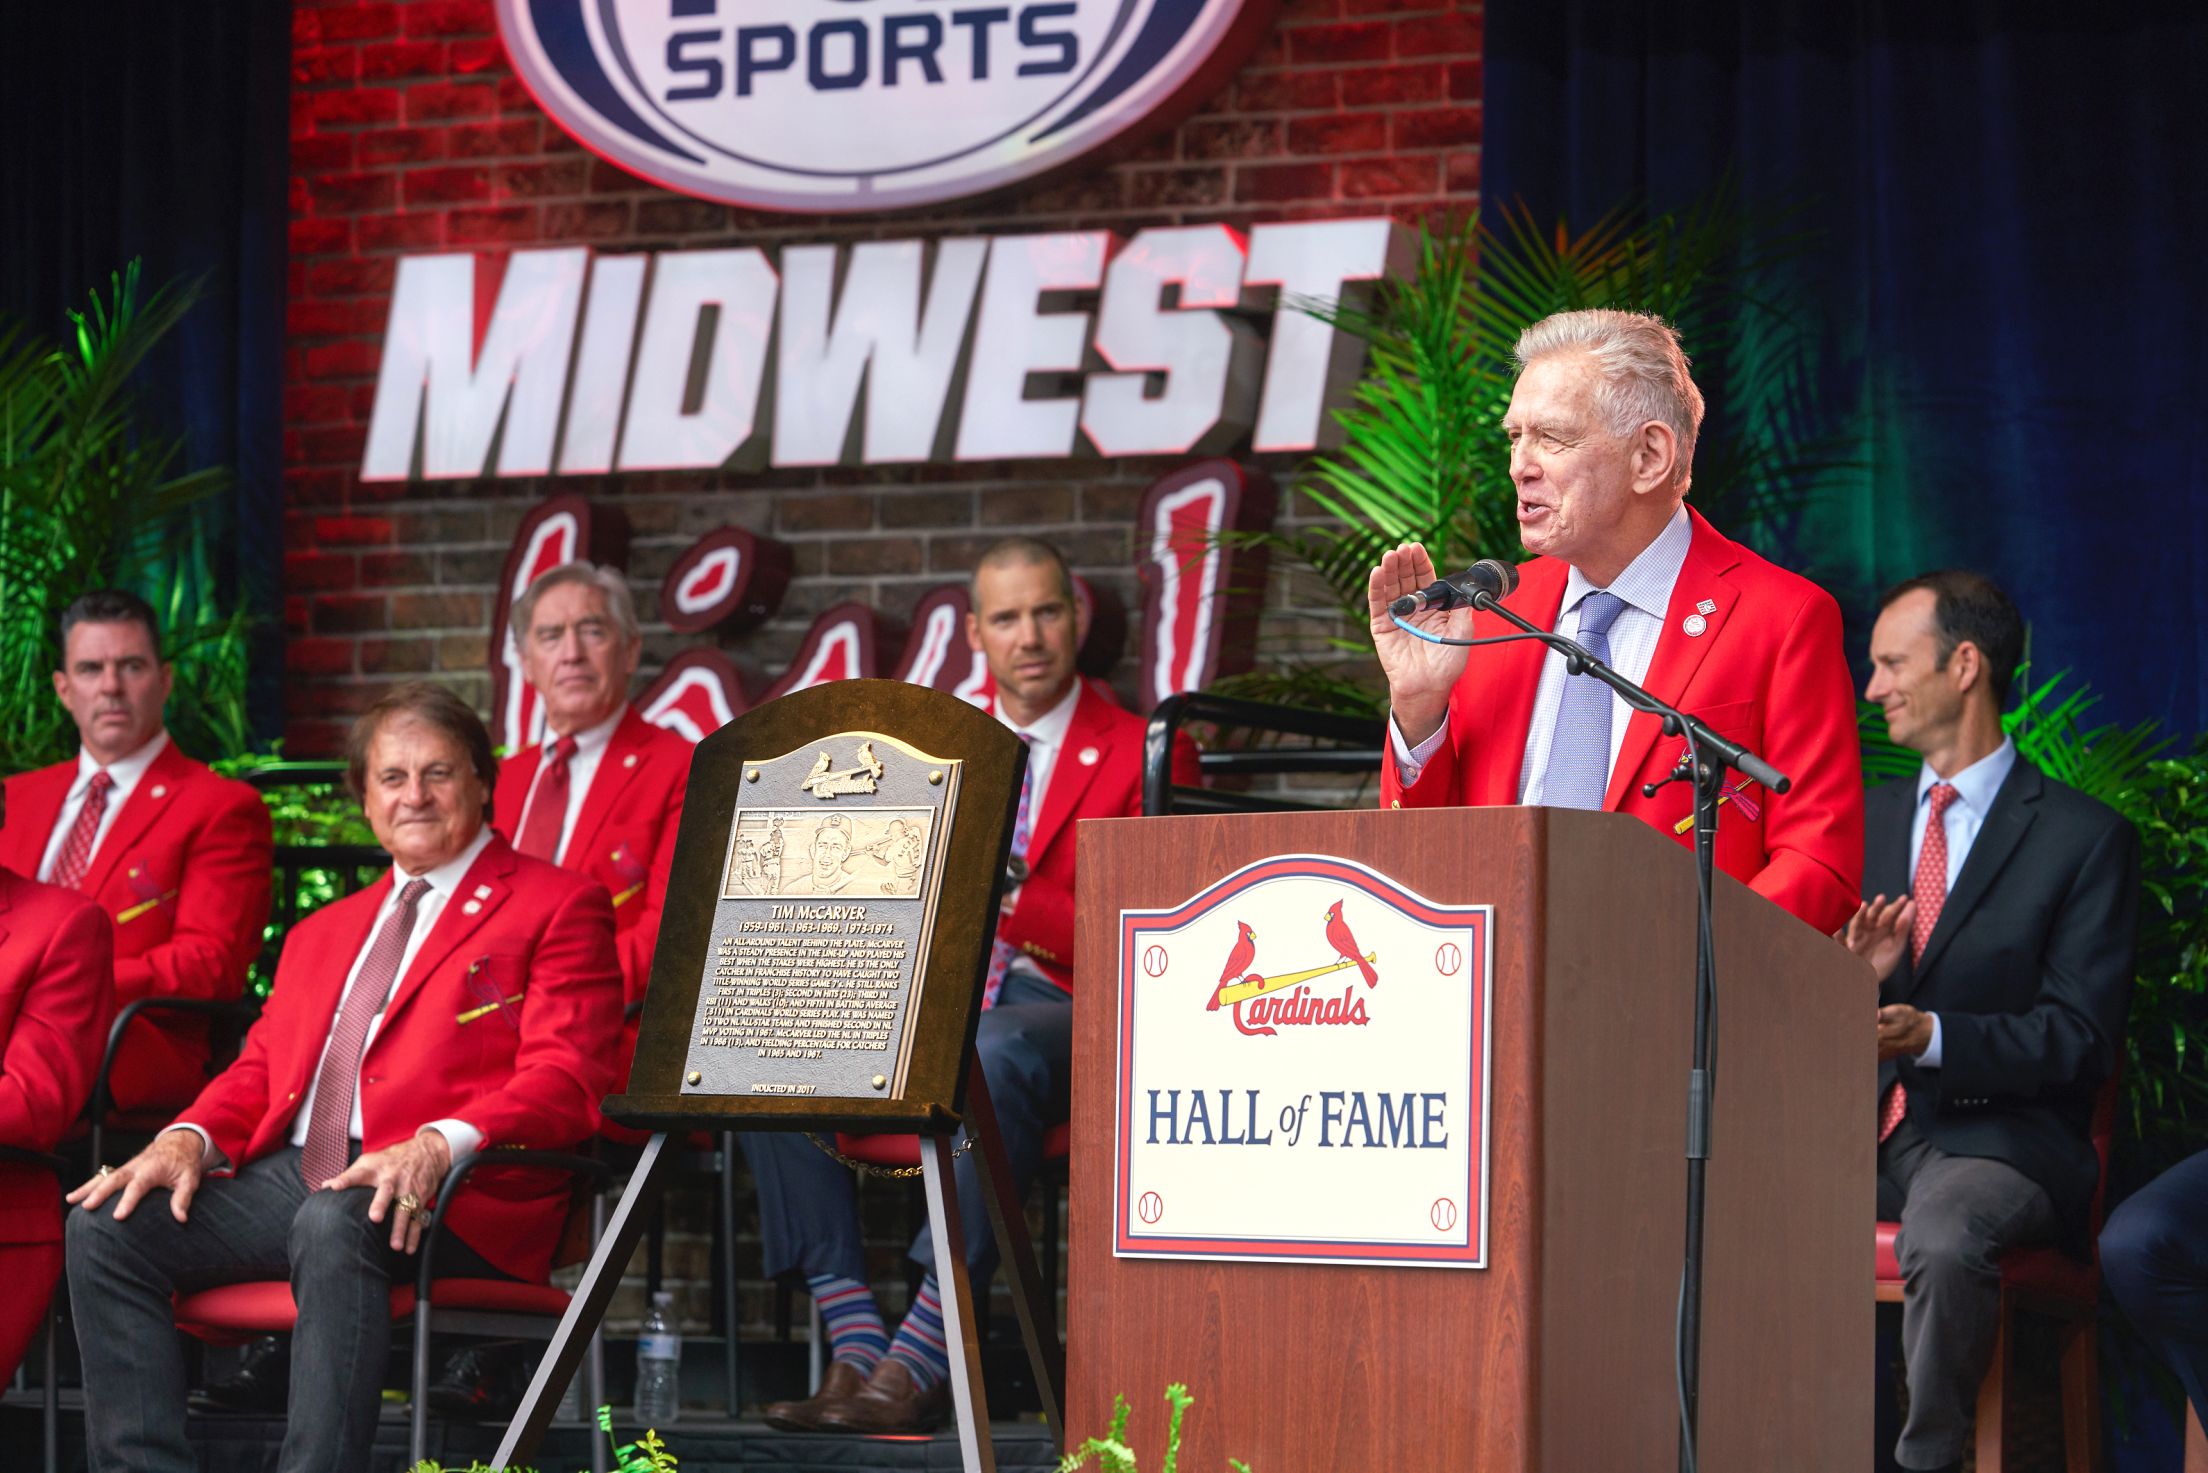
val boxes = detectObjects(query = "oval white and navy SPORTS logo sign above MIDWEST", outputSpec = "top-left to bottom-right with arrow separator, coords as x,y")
499,0 -> 1276,212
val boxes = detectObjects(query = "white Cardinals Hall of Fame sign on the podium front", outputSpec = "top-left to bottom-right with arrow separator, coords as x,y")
1113,855 -> 1493,1268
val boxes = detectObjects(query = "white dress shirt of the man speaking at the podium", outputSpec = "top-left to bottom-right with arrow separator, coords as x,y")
1389,506 -> 1694,804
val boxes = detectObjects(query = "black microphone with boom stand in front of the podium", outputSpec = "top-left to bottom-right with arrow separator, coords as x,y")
1391,600 -> 1793,1473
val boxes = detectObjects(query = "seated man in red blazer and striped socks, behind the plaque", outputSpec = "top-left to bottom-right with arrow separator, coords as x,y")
742,537 -> 1199,1431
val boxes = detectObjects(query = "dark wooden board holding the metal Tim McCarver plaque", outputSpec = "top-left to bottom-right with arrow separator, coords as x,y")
605,680 -> 1027,1131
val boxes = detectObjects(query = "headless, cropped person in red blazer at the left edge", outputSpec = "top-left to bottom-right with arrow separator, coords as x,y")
0,788 -> 115,1380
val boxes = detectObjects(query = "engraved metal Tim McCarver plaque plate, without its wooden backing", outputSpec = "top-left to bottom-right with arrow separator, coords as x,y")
682,731 -> 963,1098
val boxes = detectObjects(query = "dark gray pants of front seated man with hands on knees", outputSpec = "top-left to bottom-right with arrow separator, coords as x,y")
68,1148 -> 508,1473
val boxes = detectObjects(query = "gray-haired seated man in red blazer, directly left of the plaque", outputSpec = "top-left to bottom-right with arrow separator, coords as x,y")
492,563 -> 691,1087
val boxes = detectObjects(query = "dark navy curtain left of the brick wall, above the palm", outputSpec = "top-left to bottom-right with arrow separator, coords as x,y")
0,0 -> 291,738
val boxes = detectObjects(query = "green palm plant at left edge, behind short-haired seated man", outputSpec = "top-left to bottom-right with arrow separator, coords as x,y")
0,261 -> 250,771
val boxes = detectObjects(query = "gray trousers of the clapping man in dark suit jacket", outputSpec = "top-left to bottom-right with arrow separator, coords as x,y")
1879,1120 -> 2056,1469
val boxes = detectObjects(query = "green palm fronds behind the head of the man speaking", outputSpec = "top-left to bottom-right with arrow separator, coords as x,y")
1221,183 -> 1848,713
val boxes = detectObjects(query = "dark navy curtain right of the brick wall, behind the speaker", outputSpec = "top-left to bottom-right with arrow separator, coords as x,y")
1482,0 -> 2208,733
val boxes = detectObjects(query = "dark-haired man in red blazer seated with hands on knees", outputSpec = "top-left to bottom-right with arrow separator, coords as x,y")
68,682 -> 620,1473
